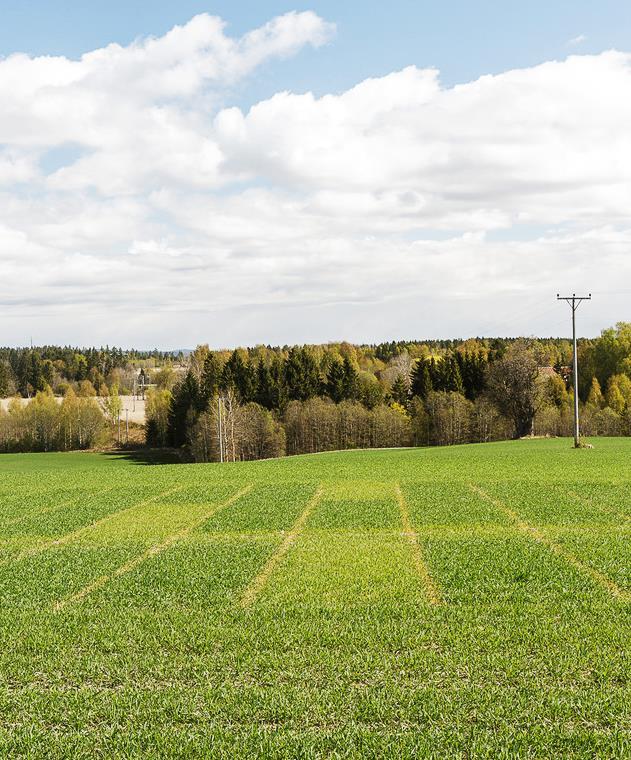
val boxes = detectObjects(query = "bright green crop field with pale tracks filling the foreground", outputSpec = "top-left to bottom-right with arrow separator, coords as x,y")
0,439 -> 631,758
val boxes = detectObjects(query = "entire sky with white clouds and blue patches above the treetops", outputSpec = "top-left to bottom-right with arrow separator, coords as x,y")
0,0 -> 631,349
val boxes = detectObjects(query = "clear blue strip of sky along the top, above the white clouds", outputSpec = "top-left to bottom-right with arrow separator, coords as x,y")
0,0 -> 631,101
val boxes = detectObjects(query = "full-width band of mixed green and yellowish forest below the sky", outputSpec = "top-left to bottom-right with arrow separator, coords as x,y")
0,323 -> 631,454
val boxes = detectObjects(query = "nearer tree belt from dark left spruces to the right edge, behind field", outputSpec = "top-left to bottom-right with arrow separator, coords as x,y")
147,323 -> 631,461
